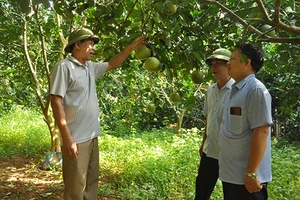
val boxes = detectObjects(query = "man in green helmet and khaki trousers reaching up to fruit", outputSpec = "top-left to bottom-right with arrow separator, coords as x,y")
50,28 -> 147,200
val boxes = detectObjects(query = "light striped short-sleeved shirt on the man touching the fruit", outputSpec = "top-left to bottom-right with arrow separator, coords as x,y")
50,56 -> 108,143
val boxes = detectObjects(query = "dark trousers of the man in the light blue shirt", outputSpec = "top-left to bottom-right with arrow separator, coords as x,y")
222,182 -> 268,200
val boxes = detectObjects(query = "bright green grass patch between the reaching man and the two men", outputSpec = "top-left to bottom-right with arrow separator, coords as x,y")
99,129 -> 206,199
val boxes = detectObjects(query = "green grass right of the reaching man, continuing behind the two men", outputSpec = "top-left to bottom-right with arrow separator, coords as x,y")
99,130 -> 300,200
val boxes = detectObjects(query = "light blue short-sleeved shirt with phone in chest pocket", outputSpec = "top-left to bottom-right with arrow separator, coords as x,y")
219,74 -> 272,185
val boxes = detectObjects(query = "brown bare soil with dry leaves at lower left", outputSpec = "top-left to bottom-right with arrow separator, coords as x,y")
0,158 -> 115,200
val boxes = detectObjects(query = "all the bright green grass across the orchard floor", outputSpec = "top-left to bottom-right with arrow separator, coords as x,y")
0,109 -> 300,200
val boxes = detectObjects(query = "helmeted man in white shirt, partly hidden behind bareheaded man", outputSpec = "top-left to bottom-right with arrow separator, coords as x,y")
195,48 -> 234,200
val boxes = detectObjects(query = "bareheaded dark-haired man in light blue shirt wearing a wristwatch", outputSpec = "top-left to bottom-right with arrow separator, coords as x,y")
219,44 -> 272,200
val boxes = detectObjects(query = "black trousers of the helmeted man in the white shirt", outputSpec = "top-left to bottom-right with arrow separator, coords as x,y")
195,153 -> 219,200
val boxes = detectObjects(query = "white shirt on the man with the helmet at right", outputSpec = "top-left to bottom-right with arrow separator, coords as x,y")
203,78 -> 234,159
